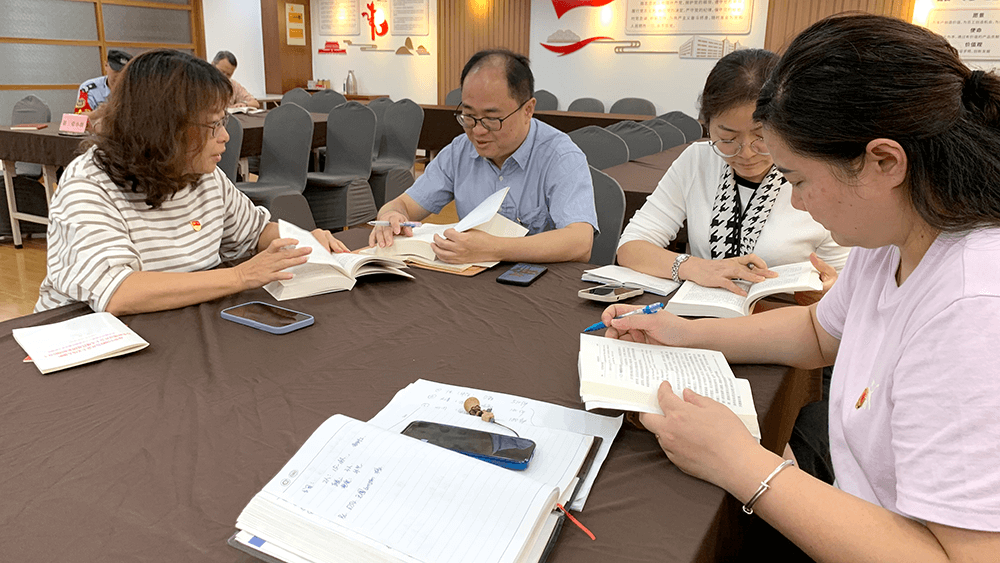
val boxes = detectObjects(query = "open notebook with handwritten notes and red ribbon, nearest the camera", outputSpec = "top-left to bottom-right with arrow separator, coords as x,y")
230,415 -> 583,563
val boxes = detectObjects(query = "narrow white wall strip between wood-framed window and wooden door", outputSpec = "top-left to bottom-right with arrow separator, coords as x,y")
202,0 -> 268,96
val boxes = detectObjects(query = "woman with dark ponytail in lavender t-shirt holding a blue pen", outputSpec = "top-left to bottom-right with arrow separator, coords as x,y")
603,15 -> 1000,562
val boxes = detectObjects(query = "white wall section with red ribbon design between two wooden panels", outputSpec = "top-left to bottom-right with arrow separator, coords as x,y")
529,0 -> 768,117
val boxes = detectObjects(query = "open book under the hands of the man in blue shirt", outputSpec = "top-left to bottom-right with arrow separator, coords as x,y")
361,188 -> 528,272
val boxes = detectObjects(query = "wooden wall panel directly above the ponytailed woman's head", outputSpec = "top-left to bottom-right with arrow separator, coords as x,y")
764,0 -> 916,53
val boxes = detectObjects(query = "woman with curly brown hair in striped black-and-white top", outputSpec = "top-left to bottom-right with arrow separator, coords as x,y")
35,49 -> 347,315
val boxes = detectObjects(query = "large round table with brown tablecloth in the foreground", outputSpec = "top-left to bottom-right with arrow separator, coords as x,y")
0,229 -> 818,563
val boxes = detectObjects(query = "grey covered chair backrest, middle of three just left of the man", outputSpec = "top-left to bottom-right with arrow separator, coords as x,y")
323,102 -> 378,179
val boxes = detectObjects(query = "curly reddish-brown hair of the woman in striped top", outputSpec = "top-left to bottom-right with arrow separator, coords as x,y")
88,49 -> 233,208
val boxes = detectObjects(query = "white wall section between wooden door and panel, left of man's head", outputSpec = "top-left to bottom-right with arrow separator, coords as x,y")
310,0 -> 438,104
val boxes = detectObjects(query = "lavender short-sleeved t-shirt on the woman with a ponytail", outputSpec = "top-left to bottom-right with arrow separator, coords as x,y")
818,229 -> 1000,531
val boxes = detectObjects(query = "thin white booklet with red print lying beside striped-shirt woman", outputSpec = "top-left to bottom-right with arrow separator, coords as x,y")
11,313 -> 149,374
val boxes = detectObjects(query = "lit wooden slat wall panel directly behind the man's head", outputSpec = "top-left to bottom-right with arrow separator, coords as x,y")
437,0 -> 531,104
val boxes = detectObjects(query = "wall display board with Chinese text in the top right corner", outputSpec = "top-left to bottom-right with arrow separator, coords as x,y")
913,0 -> 1000,61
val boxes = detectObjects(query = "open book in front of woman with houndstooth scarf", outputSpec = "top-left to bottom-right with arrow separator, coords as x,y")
665,262 -> 823,318
